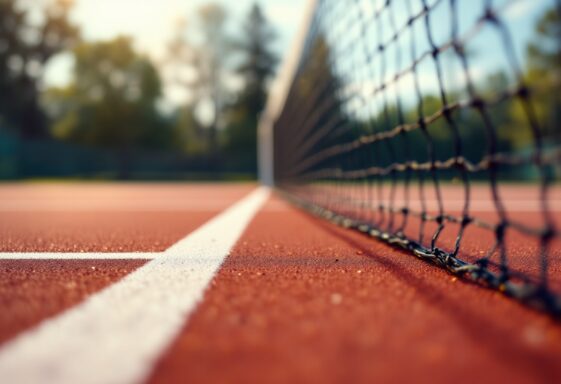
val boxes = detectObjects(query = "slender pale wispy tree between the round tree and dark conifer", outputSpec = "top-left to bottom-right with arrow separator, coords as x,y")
166,3 -> 230,166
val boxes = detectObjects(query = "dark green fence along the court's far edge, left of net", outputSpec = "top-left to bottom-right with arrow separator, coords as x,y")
0,129 -> 255,180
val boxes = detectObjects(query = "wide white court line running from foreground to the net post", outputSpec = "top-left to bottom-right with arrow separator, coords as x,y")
0,187 -> 270,384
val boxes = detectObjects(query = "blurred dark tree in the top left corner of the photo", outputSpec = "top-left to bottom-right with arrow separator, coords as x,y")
0,0 -> 78,138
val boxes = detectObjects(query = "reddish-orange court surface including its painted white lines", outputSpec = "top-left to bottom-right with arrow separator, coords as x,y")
0,183 -> 561,383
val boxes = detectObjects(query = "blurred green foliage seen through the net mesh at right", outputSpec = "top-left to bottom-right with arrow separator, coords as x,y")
365,4 -> 561,170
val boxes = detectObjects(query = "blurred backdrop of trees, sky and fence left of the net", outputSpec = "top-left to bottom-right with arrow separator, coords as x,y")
0,0 -> 305,180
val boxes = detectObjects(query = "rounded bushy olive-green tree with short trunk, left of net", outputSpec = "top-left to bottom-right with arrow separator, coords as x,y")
45,37 -> 174,178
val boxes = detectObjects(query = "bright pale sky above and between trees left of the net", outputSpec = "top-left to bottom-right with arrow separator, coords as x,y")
45,0 -> 307,105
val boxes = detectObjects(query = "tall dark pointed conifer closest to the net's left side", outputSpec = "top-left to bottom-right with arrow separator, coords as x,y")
223,4 -> 278,172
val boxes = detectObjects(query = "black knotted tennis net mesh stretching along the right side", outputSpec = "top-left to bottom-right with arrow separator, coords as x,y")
273,0 -> 561,315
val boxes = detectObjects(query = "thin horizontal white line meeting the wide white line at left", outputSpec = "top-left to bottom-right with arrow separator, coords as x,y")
0,252 -> 156,260
